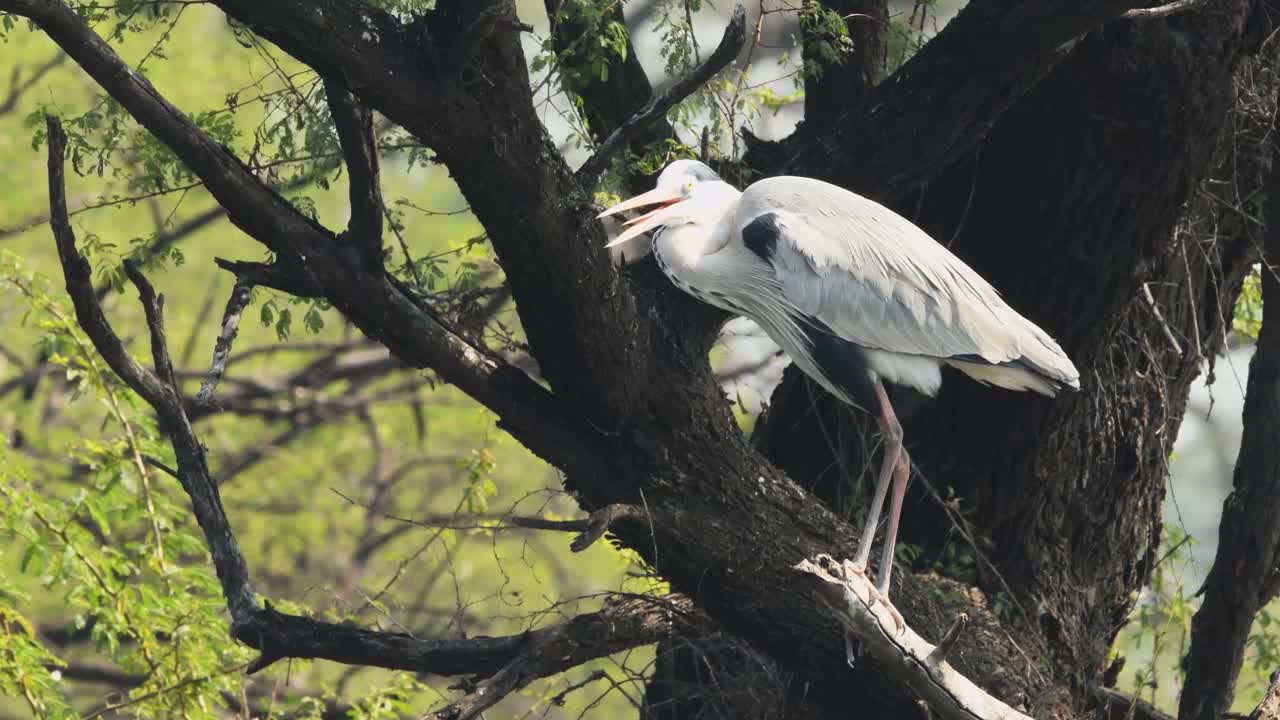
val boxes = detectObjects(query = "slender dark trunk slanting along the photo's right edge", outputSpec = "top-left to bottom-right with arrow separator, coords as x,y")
1178,106 -> 1280,720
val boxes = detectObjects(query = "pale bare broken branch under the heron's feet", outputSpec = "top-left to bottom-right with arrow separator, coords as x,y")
796,555 -> 1032,720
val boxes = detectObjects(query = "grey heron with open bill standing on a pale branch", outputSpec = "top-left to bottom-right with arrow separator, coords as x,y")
599,160 -> 1080,600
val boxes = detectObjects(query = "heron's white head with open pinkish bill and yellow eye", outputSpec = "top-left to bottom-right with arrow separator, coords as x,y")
596,160 -> 740,247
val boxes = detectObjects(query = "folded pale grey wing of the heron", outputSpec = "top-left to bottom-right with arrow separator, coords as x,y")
737,177 -> 1078,387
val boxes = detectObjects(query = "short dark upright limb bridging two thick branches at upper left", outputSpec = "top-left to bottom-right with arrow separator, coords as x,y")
325,78 -> 385,266
